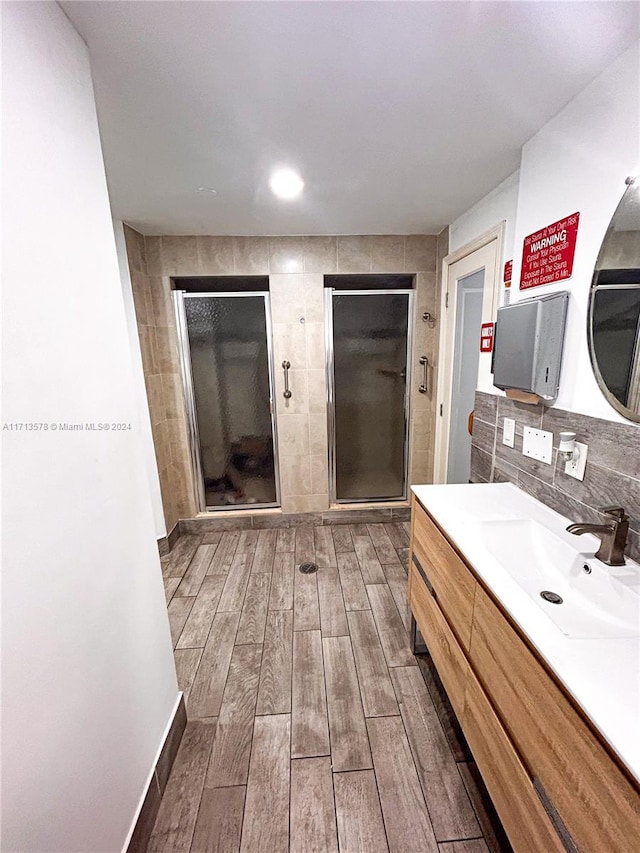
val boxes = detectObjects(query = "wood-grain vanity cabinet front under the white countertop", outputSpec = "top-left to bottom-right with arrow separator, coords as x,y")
409,497 -> 640,853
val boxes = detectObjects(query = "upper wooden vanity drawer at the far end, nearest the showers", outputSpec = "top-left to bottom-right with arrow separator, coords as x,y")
411,499 -> 476,651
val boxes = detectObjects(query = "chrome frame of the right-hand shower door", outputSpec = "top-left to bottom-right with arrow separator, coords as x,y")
324,287 -> 415,505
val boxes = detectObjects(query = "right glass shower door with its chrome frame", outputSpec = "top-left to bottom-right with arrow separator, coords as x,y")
325,287 -> 414,503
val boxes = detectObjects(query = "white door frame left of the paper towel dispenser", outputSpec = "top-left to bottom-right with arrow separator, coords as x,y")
433,220 -> 506,483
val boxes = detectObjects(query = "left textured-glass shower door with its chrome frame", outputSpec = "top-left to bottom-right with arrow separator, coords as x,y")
174,291 -> 280,511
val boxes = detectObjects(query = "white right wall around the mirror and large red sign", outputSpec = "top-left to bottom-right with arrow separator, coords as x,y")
451,44 -> 640,421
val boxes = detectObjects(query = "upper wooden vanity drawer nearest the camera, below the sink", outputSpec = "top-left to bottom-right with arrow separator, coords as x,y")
469,587 -> 640,853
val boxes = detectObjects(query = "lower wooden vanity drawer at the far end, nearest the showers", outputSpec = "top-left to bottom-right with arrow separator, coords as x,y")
409,564 -> 469,719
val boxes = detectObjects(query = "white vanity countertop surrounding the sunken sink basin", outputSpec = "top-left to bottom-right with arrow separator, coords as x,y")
412,483 -> 640,781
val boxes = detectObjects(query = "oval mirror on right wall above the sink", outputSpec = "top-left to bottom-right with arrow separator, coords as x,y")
588,178 -> 640,422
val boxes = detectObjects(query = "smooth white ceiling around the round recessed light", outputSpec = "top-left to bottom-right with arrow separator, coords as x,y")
61,0 -> 640,234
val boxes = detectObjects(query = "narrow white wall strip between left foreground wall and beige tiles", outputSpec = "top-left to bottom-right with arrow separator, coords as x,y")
113,219 -> 167,539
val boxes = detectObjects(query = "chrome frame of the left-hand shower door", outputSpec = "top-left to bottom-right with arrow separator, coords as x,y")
173,290 -> 281,512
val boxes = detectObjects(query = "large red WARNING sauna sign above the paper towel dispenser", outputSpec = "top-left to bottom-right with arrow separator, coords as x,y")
520,213 -> 580,290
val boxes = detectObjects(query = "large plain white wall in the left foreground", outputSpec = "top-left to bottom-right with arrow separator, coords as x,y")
2,3 -> 178,853
